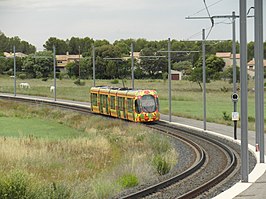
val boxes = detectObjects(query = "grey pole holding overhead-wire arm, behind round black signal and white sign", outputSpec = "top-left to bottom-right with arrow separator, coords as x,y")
232,12 -> 237,140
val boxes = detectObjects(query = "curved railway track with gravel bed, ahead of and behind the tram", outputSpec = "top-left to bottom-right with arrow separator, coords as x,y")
0,95 -> 239,198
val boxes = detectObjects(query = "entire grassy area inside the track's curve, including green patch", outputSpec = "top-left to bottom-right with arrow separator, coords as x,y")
0,100 -> 178,198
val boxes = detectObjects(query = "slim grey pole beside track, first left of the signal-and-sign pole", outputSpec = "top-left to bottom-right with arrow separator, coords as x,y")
202,29 -> 206,130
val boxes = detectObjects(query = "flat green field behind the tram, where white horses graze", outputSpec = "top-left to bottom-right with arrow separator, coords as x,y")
0,76 -> 266,130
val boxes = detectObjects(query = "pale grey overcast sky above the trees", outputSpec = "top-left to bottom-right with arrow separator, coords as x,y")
0,0 -> 266,50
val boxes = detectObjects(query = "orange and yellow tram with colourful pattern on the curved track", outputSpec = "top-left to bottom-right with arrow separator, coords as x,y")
90,86 -> 160,122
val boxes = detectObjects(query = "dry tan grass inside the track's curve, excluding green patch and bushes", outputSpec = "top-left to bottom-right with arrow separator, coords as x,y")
0,101 -> 178,198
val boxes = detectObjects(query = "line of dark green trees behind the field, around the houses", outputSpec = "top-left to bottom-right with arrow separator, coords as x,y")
0,33 -> 266,84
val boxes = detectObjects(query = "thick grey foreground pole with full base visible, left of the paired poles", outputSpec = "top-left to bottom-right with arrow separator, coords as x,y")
239,0 -> 249,182
